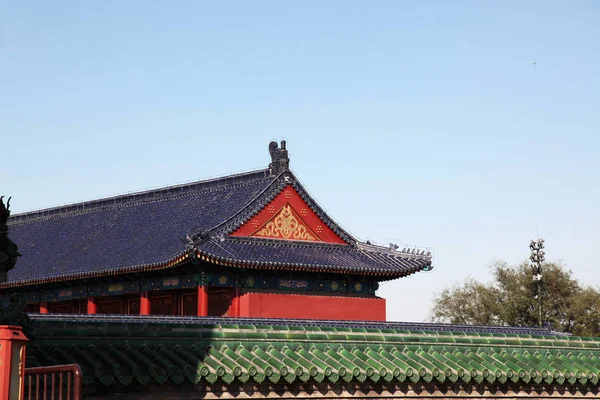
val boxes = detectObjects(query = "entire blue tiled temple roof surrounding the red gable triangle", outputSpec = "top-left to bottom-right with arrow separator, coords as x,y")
2,170 -> 431,286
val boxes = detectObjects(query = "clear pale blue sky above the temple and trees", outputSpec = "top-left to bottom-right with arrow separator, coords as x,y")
0,0 -> 600,321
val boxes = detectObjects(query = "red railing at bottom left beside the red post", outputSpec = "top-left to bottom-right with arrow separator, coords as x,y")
24,364 -> 81,400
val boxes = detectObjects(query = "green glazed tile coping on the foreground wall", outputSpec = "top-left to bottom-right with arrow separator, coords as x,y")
27,320 -> 600,386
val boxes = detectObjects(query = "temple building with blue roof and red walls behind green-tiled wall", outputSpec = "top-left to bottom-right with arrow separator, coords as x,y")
0,142 -> 432,321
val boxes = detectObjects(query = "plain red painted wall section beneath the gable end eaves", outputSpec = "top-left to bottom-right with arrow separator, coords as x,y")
240,293 -> 385,321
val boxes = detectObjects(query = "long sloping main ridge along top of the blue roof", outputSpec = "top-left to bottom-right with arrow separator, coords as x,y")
8,168 -> 270,226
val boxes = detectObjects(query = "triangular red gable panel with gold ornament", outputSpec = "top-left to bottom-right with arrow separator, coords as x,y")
231,185 -> 346,244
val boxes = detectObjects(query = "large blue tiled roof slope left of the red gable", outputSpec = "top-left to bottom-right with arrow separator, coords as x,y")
8,171 -> 273,282
